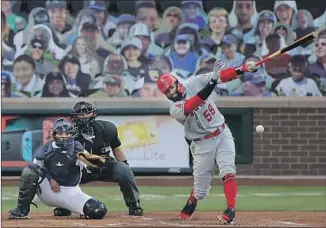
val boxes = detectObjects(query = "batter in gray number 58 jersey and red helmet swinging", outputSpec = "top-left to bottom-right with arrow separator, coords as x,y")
157,60 -> 257,224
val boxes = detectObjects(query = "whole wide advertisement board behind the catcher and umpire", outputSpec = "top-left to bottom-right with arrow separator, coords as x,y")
1,115 -> 190,173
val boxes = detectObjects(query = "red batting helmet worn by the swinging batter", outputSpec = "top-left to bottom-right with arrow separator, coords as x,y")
156,73 -> 184,101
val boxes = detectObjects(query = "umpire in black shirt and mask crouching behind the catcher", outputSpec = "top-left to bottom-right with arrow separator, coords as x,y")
54,101 -> 143,216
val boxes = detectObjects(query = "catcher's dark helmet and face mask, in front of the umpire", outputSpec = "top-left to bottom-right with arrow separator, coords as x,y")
52,118 -> 76,150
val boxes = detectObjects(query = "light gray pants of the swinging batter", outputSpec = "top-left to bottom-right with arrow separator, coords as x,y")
190,126 -> 236,200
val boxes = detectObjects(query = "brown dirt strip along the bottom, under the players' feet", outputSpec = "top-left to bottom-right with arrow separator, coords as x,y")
2,211 -> 326,228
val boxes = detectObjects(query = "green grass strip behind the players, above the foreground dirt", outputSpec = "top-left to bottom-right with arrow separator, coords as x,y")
2,186 -> 326,212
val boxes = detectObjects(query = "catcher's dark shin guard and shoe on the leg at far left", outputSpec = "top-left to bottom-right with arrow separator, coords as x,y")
8,165 -> 42,219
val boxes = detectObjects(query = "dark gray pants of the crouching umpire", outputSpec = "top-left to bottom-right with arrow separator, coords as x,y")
81,160 -> 139,207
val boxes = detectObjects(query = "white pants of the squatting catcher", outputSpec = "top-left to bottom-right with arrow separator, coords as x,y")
37,178 -> 92,215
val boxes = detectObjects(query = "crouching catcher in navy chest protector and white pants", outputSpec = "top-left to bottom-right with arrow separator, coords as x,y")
8,118 -> 107,219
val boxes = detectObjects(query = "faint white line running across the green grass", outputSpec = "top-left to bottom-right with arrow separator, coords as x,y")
1,192 -> 326,201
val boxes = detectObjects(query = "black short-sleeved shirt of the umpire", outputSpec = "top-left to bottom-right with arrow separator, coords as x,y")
76,120 -> 121,155
